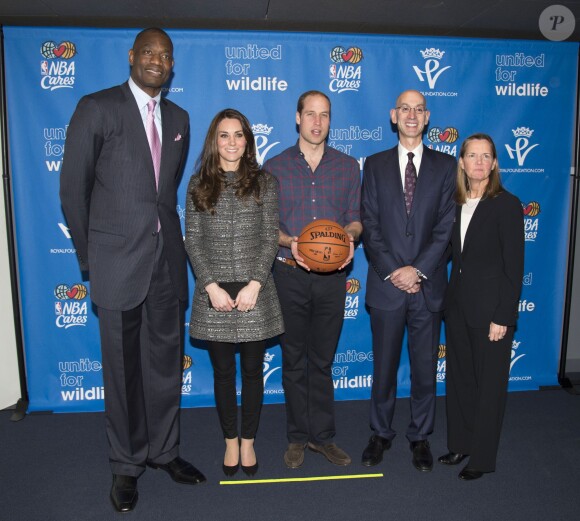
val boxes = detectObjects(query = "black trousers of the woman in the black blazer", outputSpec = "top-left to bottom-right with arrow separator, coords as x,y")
445,301 -> 514,472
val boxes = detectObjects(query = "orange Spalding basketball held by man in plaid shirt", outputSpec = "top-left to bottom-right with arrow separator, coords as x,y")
298,219 -> 350,273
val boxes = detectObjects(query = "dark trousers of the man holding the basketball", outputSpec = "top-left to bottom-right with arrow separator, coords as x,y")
274,261 -> 346,444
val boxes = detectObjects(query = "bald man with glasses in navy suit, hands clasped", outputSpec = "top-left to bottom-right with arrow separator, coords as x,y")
361,90 -> 456,471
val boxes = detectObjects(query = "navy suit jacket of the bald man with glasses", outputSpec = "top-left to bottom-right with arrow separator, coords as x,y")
361,147 -> 457,312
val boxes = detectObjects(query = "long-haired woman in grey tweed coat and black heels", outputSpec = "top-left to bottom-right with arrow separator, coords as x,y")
185,109 -> 284,476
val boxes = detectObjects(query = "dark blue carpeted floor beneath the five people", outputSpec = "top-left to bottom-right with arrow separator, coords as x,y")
0,390 -> 580,521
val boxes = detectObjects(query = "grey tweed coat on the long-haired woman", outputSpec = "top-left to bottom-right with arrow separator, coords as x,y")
185,172 -> 284,342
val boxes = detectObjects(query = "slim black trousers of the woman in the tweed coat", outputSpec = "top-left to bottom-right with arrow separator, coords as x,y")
207,340 -> 266,439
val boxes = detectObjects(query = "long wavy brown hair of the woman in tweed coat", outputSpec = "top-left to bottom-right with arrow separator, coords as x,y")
191,109 -> 262,214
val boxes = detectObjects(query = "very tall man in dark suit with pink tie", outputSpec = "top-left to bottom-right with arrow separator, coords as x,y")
60,28 -> 205,512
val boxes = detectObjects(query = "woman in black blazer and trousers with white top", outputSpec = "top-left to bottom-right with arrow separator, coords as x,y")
439,134 -> 524,480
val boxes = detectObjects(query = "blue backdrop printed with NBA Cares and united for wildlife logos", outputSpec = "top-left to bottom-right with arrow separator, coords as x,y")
4,27 -> 578,411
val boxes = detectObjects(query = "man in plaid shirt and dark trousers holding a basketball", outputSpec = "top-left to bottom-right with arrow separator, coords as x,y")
264,91 -> 362,468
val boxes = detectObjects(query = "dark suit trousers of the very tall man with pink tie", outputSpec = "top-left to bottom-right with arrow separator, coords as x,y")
98,235 -> 185,476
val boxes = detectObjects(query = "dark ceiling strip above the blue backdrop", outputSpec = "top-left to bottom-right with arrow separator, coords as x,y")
0,0 -> 580,41
